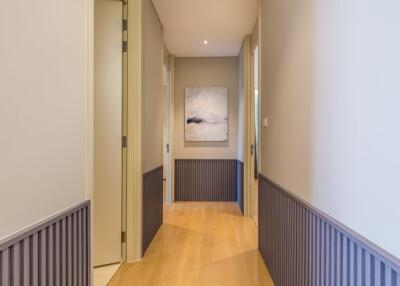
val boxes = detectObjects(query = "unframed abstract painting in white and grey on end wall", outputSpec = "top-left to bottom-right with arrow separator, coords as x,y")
185,87 -> 228,141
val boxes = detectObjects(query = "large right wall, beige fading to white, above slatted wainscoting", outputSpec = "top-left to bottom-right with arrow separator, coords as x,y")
261,0 -> 400,257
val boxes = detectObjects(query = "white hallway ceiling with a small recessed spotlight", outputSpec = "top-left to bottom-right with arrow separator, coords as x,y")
153,0 -> 258,57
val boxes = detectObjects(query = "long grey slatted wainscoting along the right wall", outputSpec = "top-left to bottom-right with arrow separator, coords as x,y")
259,175 -> 400,286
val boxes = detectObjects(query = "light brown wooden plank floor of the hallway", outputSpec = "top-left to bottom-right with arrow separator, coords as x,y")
109,202 -> 273,286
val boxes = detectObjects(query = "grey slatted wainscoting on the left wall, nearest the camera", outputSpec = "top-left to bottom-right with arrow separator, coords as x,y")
0,201 -> 90,286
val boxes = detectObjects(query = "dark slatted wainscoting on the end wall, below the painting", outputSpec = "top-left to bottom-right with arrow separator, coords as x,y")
175,159 -> 237,202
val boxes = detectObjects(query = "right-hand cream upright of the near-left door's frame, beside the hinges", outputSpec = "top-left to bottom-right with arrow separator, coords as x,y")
126,0 -> 143,262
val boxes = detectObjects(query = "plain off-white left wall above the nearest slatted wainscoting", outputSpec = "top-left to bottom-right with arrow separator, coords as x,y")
0,0 -> 87,239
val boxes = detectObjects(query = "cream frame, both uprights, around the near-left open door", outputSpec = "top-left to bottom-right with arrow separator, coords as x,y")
83,0 -> 142,276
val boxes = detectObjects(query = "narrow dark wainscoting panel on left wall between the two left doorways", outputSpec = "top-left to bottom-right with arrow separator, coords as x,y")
142,166 -> 163,254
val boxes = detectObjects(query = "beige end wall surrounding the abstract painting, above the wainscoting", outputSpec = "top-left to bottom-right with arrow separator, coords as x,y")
175,57 -> 238,159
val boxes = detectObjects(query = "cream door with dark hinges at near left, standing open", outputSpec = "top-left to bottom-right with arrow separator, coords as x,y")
93,0 -> 122,266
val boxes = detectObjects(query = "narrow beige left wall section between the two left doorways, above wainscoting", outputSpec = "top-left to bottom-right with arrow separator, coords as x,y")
142,0 -> 163,173
